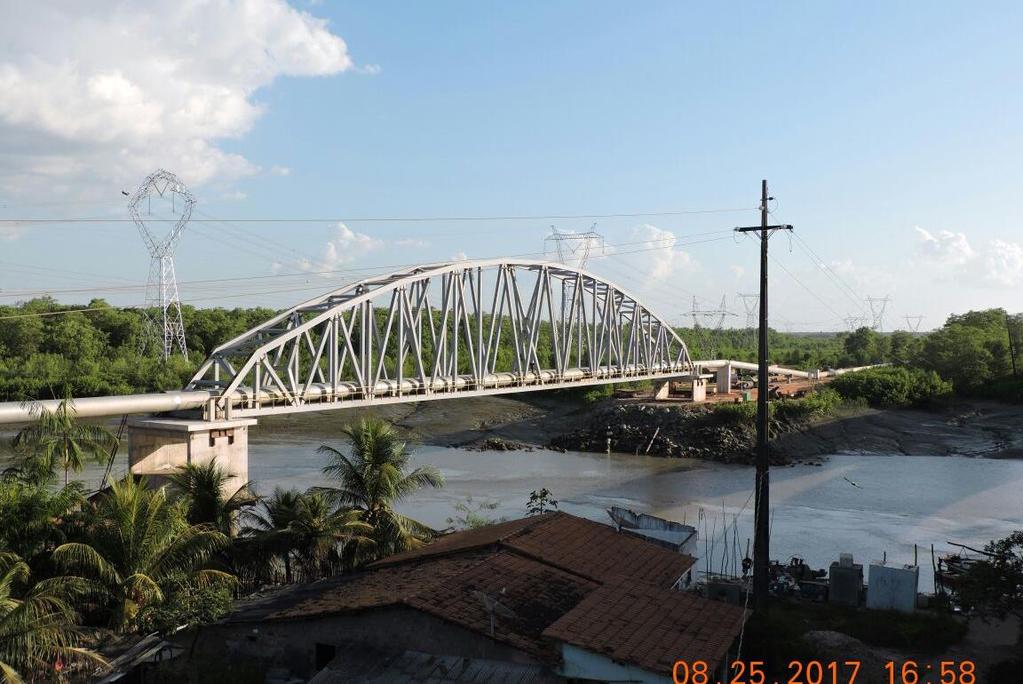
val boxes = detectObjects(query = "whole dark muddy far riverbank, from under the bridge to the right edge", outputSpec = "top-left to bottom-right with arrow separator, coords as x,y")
302,393 -> 1023,463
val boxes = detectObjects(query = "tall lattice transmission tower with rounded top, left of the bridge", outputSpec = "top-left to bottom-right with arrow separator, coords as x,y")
128,169 -> 195,360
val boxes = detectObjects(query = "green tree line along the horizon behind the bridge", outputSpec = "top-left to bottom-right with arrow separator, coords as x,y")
0,298 -> 1023,401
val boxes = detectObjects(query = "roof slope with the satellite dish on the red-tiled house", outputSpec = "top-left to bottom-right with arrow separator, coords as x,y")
406,551 -> 598,658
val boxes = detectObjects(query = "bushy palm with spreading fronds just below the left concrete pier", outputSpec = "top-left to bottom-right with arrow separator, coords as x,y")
53,475 -> 235,632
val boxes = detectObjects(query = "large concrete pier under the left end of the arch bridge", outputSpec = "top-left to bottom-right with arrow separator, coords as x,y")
128,418 -> 257,496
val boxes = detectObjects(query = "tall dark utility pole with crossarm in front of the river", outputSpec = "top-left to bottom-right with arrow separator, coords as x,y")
736,181 -> 792,610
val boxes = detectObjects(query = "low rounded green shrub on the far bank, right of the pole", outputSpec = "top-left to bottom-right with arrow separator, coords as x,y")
829,366 -> 952,408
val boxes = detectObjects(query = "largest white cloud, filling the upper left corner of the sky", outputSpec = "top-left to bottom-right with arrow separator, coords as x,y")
0,0 -> 353,196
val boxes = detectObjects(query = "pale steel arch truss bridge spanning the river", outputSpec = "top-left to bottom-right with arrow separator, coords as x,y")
186,260 -> 693,420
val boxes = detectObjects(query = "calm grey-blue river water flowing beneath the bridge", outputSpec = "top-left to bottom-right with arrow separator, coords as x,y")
4,419 -> 1023,591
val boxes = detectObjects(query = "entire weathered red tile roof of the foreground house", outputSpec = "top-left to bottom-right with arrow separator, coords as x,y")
229,512 -> 744,672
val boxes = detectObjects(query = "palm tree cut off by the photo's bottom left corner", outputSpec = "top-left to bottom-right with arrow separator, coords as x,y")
0,553 -> 104,684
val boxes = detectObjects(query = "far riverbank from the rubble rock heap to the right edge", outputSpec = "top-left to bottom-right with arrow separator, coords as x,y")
550,394 -> 1023,465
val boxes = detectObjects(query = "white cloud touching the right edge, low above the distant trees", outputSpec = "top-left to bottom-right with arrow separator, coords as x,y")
916,226 -> 1023,287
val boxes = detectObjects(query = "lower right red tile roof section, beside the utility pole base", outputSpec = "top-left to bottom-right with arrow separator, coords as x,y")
543,579 -> 749,674
